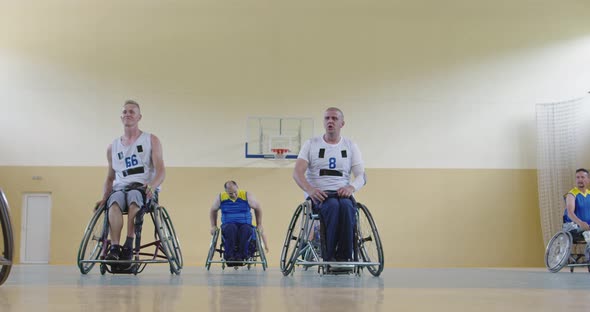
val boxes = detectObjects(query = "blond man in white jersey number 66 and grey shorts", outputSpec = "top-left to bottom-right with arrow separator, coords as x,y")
99,100 -> 166,260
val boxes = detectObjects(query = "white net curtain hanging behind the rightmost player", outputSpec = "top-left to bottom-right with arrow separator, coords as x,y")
536,98 -> 583,245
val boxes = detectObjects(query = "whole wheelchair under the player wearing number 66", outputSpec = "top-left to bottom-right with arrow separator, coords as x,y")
77,190 -> 183,275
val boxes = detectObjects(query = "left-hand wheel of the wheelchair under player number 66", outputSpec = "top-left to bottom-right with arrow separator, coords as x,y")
77,207 -> 108,274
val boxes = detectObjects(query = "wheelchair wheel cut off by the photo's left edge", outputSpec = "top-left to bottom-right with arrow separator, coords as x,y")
0,189 -> 14,285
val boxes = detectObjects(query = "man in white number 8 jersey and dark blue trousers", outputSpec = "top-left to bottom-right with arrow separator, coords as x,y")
293,107 -> 365,261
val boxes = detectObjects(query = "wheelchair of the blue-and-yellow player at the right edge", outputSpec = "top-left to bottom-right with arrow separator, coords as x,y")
545,230 -> 590,273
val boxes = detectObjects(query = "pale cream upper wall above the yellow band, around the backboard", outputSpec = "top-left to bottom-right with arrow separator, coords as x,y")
0,0 -> 590,169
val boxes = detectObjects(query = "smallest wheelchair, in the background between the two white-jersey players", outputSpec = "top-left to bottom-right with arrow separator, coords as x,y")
205,227 -> 268,271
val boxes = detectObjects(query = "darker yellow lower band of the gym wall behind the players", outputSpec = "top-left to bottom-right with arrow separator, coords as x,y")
0,167 -> 543,267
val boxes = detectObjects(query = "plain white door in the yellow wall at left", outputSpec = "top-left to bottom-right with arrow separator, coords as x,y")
20,193 -> 51,263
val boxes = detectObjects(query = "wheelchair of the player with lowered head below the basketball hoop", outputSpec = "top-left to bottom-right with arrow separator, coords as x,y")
205,226 -> 268,271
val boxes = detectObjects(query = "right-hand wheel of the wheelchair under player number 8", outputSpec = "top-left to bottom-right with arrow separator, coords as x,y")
357,203 -> 384,276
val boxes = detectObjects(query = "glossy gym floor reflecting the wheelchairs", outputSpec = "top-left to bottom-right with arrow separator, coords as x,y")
0,265 -> 590,312
